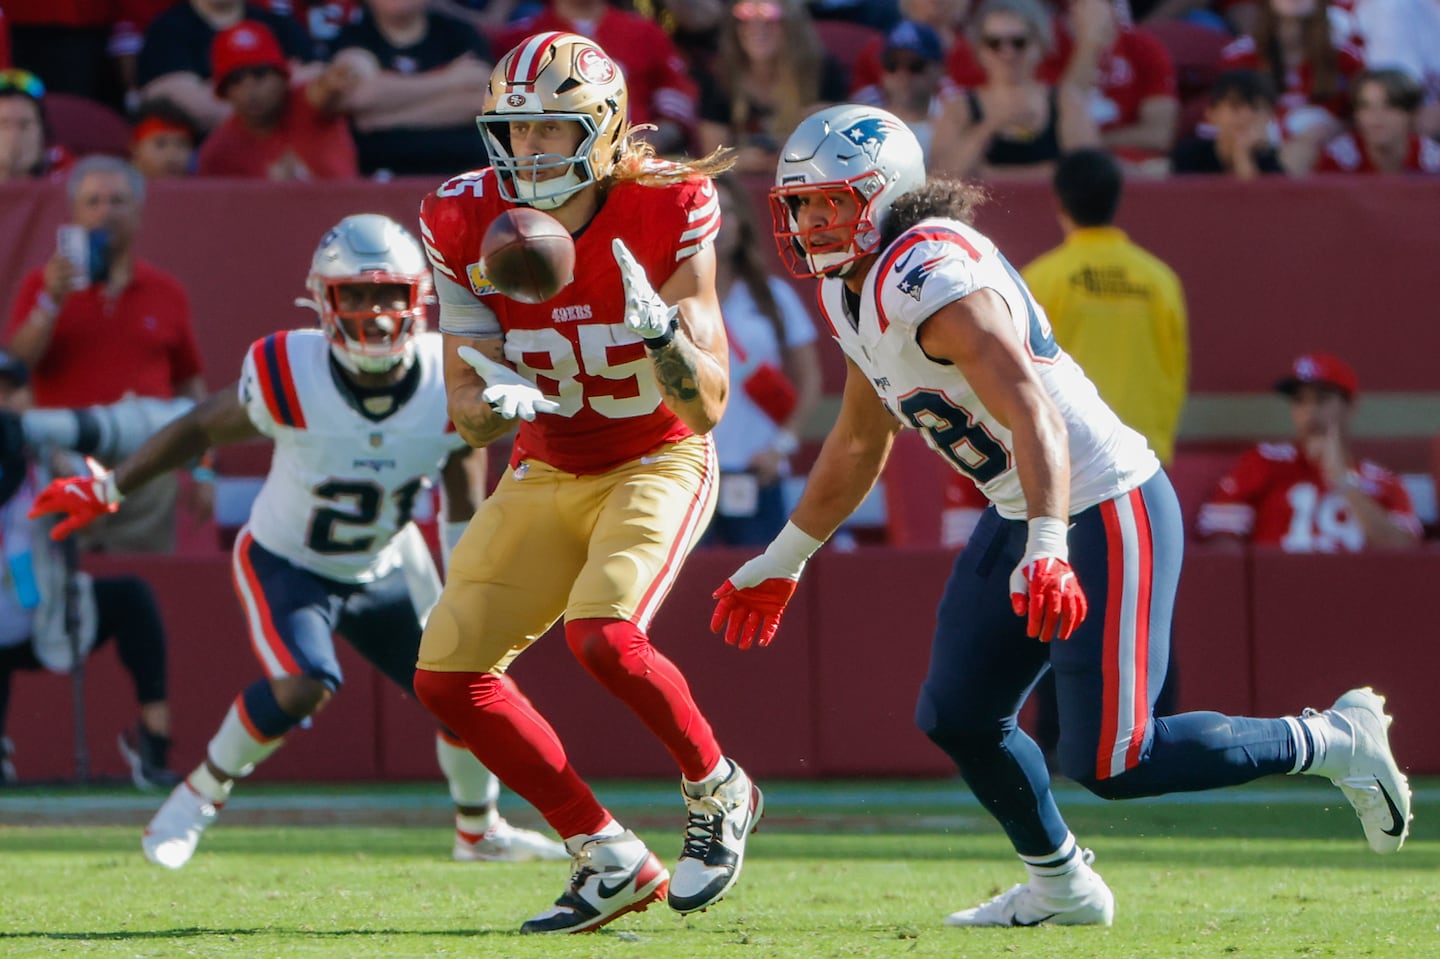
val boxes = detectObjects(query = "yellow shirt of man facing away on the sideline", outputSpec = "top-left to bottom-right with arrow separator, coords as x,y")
1021,226 -> 1189,464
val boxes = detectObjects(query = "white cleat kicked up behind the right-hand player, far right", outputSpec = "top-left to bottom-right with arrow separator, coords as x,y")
1302,685 -> 1413,852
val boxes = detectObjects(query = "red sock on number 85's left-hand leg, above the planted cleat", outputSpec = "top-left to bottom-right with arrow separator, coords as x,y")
415,670 -> 611,839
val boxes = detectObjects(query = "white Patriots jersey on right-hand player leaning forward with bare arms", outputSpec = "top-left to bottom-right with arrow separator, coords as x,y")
819,219 -> 1159,520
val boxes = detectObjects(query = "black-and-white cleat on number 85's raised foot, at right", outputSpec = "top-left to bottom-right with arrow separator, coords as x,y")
667,760 -> 765,913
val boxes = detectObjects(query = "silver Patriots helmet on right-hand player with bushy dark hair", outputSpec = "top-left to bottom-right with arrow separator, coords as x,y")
770,104 -> 924,276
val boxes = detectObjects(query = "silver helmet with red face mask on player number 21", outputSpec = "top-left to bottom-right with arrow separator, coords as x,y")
295,213 -> 433,373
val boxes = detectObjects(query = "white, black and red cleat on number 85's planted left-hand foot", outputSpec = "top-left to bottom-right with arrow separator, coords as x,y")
520,829 -> 670,933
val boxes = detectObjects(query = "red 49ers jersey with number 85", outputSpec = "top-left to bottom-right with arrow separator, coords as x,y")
420,170 -> 720,474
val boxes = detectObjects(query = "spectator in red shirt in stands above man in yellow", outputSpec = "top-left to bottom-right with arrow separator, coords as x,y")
1040,0 -> 1179,163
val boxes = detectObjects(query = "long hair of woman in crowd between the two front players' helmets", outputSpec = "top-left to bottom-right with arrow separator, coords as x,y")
716,0 -> 825,141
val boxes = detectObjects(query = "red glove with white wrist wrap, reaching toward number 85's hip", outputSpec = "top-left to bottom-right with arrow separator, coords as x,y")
710,523 -> 822,649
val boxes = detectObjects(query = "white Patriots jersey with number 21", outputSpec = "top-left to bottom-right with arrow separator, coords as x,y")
239,330 -> 465,583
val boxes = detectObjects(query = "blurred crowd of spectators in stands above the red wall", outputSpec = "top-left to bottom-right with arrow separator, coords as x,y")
0,0 -> 1440,180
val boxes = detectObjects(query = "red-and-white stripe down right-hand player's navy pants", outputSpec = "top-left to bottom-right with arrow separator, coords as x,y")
1094,488 -> 1152,779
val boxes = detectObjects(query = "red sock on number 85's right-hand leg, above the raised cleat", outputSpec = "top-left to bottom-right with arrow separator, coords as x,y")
564,619 -> 721,782
